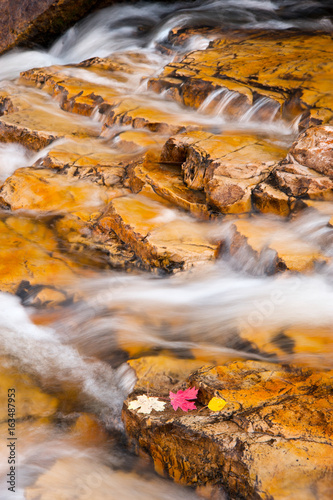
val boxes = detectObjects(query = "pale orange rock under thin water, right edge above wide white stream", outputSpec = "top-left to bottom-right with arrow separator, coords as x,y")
222,218 -> 328,273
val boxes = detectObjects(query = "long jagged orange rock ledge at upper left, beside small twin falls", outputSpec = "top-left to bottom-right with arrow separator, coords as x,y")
20,66 -> 196,137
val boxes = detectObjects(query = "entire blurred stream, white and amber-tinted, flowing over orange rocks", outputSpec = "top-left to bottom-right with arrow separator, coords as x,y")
0,0 -> 333,500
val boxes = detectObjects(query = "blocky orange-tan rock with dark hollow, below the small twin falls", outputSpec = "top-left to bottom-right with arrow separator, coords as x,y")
161,132 -> 285,213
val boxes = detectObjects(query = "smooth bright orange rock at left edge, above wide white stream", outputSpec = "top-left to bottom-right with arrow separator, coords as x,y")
0,213 -> 85,298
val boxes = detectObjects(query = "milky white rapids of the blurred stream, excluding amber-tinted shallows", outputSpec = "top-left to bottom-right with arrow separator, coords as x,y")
0,0 -> 333,500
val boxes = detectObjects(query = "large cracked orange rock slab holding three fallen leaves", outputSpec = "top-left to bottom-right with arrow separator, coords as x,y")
123,361 -> 333,500
